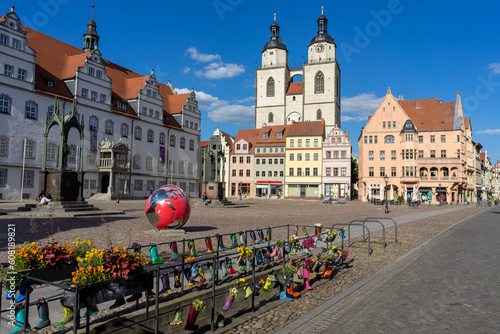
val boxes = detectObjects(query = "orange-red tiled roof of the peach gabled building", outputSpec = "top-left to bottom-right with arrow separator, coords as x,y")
398,98 -> 455,131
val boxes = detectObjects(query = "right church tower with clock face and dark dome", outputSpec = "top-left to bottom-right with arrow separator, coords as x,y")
304,7 -> 340,133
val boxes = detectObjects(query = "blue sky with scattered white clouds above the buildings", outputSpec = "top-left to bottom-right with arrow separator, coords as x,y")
11,0 -> 500,163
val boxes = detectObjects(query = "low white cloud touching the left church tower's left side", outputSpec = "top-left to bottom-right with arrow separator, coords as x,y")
175,88 -> 255,125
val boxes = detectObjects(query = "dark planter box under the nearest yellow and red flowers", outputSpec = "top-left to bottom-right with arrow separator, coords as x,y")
64,271 -> 153,308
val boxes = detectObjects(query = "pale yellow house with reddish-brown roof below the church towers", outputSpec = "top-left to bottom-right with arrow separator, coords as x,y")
285,120 -> 325,199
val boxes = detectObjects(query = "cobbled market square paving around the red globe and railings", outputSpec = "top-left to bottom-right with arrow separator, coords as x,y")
0,199 -> 483,333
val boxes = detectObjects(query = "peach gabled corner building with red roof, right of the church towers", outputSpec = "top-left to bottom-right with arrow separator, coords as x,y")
358,88 -> 470,203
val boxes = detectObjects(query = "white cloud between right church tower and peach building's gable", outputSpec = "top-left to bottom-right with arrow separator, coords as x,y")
341,93 -> 383,122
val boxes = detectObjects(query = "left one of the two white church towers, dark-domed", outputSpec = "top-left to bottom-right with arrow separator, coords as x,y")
255,14 -> 289,128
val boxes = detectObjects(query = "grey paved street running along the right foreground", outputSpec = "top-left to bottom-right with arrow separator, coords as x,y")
277,208 -> 500,333
